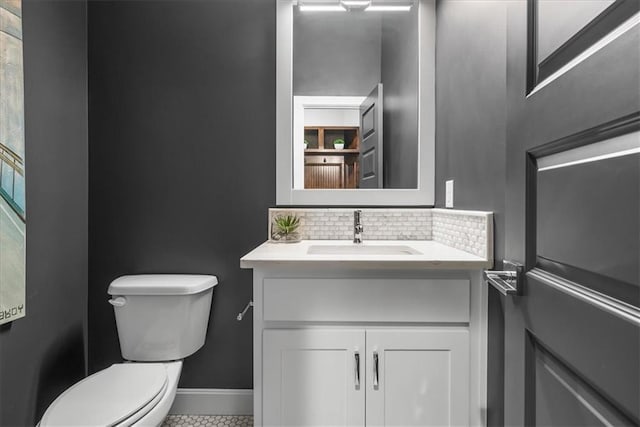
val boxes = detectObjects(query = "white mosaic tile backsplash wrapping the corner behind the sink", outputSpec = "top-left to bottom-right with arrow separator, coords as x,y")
268,208 -> 493,259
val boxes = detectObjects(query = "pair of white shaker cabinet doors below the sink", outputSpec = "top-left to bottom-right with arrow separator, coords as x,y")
262,327 -> 469,426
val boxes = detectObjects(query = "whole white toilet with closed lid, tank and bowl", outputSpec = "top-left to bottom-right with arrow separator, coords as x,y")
38,274 -> 218,427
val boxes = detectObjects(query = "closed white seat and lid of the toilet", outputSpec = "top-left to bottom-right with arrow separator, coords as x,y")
40,363 -> 170,427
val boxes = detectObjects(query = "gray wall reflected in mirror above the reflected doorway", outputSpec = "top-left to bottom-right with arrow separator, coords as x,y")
293,7 -> 382,96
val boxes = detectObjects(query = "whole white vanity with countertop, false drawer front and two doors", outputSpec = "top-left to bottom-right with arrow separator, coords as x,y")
241,241 -> 491,427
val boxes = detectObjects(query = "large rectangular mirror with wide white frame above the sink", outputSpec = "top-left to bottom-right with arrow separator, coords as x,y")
276,0 -> 435,206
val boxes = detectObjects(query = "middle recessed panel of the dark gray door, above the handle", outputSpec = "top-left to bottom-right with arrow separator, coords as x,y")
529,141 -> 640,307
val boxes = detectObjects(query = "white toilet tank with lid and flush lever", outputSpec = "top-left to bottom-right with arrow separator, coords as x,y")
108,274 -> 218,362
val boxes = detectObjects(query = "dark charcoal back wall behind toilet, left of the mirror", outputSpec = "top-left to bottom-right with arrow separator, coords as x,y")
89,0 -> 276,388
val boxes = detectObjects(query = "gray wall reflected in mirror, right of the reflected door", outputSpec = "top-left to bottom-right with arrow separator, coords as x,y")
381,11 -> 418,188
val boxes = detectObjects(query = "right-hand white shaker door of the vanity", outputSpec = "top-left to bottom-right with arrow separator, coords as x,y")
366,327 -> 469,427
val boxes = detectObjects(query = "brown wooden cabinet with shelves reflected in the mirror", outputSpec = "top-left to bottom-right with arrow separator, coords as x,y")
304,126 -> 360,188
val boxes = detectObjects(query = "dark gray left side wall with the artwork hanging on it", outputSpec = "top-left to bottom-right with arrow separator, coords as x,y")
0,0 -> 88,426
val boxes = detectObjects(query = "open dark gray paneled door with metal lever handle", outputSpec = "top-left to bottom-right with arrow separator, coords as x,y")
504,0 -> 640,426
